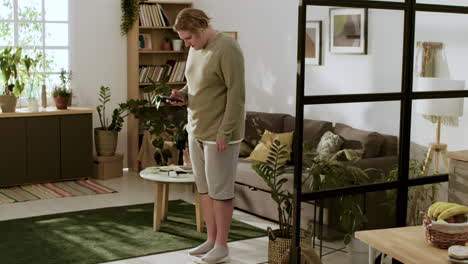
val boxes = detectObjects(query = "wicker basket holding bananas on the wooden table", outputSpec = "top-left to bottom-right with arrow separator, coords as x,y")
421,212 -> 468,248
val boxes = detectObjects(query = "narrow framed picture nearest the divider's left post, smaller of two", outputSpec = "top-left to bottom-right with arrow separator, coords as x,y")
305,21 -> 322,65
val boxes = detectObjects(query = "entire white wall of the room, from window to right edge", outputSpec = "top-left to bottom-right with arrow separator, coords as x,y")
70,0 -> 468,165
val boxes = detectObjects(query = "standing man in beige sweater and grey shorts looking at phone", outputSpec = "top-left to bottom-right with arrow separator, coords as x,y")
169,8 -> 245,263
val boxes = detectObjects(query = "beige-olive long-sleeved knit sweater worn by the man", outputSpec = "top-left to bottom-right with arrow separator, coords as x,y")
180,33 -> 245,142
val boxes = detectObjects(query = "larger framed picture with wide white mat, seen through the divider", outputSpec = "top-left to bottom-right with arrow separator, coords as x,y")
330,8 -> 367,54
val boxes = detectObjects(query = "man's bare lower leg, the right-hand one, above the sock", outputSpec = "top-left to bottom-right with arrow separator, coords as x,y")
213,199 -> 234,247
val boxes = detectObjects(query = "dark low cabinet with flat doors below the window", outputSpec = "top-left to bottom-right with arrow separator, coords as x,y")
0,114 -> 93,186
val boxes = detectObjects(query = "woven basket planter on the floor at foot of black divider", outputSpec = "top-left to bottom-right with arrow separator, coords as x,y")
268,230 -> 312,264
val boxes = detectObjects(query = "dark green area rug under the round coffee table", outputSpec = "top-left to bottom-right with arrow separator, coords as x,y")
0,200 -> 266,264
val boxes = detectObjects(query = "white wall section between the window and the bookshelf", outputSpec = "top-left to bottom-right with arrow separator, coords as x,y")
69,0 -> 127,166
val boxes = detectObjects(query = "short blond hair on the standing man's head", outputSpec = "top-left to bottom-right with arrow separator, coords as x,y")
174,8 -> 210,32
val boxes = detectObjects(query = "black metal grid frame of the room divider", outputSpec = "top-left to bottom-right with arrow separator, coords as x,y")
290,0 -> 468,263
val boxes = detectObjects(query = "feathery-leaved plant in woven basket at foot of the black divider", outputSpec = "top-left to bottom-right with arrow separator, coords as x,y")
252,140 -> 311,263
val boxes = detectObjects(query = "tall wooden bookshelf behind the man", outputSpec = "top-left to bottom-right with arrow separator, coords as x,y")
127,1 -> 192,171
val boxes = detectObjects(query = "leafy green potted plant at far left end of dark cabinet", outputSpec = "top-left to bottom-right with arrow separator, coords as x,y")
0,47 -> 25,113
